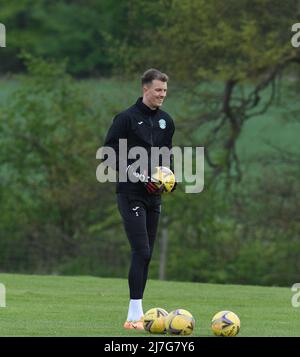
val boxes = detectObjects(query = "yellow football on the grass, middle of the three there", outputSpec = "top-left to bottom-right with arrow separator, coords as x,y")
166,309 -> 195,335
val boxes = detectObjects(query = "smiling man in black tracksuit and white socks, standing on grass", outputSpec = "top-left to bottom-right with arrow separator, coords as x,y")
105,69 -> 175,329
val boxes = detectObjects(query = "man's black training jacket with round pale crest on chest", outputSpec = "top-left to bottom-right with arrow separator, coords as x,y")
104,98 -> 175,194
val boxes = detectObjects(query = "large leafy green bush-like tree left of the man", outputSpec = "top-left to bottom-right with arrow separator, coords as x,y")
0,55 -> 122,272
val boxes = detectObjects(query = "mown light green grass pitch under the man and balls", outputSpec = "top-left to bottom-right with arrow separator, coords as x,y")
0,274 -> 300,337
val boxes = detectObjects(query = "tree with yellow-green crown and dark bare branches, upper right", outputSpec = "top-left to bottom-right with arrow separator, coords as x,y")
115,0 -> 300,186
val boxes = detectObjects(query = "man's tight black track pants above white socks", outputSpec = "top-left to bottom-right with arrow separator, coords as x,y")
117,193 -> 161,299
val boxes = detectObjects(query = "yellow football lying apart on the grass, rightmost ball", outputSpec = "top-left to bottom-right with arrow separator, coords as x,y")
211,311 -> 241,337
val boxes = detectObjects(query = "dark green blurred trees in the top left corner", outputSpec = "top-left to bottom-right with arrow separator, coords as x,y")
0,0 -> 129,77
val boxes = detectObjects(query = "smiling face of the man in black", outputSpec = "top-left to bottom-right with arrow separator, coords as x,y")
143,79 -> 167,109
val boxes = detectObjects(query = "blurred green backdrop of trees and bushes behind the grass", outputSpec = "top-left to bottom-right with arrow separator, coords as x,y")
0,0 -> 300,286
